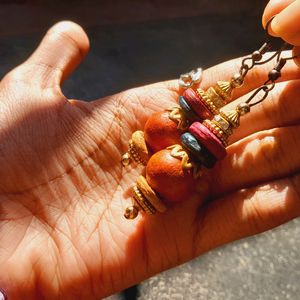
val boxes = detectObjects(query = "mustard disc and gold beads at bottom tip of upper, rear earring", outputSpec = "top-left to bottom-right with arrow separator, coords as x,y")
121,130 -> 149,166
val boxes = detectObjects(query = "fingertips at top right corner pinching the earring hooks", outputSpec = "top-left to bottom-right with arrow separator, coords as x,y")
262,0 -> 300,66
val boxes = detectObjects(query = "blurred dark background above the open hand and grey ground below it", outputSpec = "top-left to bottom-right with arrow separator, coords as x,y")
0,0 -> 300,300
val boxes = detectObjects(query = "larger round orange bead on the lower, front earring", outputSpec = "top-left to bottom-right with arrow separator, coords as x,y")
146,150 -> 196,202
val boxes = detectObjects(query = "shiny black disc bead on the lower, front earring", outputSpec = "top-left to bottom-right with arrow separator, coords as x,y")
180,132 -> 217,169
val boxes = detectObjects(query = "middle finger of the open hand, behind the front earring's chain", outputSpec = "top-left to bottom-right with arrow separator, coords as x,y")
230,80 -> 300,143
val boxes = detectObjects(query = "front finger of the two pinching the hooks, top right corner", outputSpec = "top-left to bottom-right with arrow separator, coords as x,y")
264,0 -> 300,46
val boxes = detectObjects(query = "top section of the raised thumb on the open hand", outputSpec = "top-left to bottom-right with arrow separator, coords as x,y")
24,21 -> 89,84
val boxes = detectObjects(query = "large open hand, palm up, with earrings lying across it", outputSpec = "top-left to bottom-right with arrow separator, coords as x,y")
0,22 -> 300,300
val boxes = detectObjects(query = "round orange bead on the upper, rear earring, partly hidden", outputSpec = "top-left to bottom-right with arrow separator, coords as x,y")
144,112 -> 182,152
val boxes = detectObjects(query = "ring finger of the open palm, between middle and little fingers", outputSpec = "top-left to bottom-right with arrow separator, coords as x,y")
210,125 -> 300,195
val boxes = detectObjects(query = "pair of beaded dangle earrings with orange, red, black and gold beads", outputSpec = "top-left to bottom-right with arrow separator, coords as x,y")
122,19 -> 294,219
